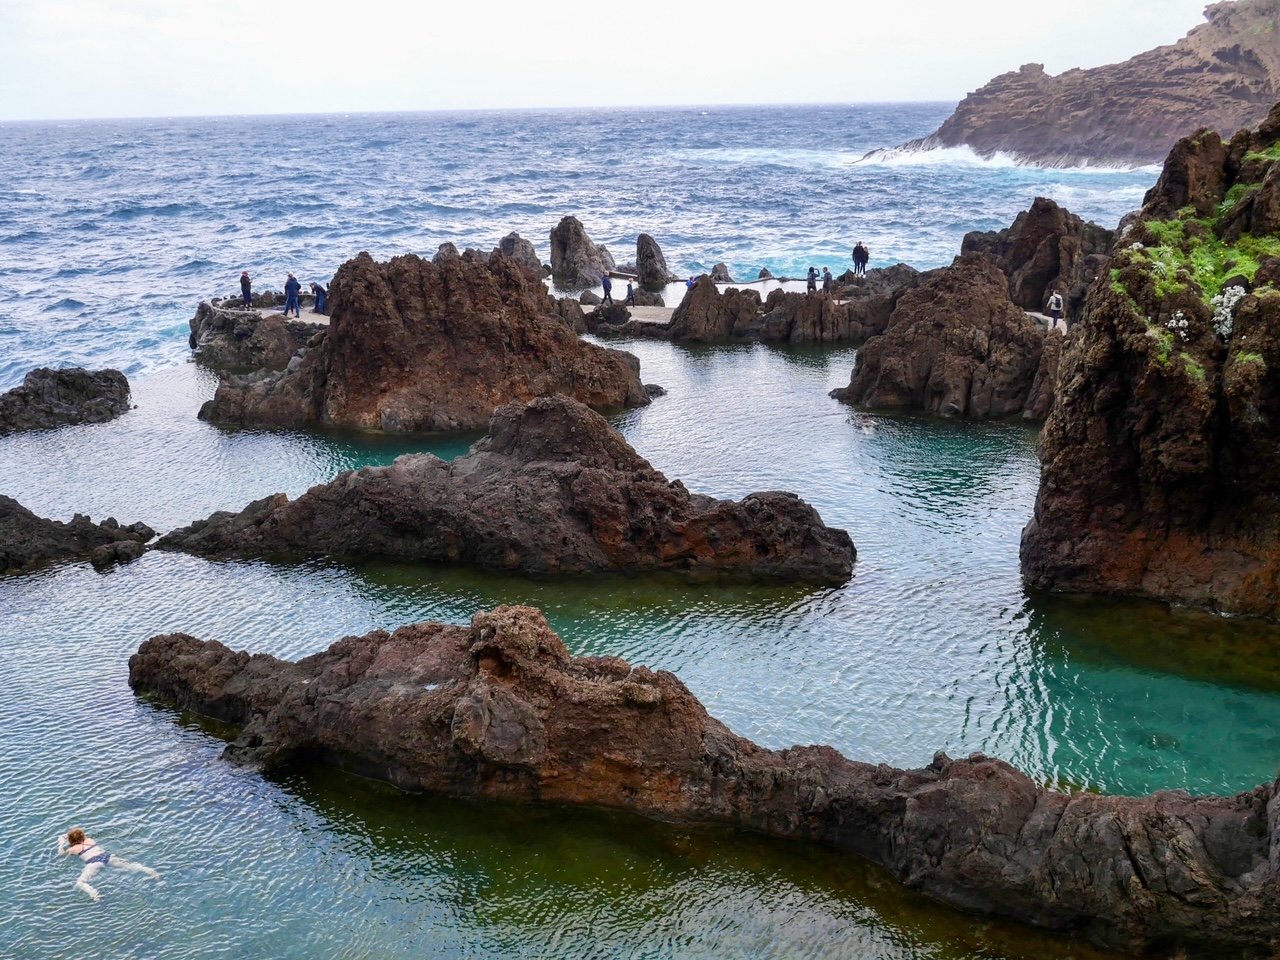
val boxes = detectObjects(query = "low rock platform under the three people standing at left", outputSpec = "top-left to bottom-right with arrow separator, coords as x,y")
188,302 -> 325,370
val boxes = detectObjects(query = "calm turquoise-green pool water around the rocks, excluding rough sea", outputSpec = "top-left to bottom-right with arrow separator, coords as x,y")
0,343 -> 1280,960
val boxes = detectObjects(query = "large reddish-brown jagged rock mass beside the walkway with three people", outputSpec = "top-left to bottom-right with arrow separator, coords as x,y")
200,253 -> 648,433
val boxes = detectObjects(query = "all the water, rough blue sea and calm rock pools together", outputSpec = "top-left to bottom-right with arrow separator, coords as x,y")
0,104 -> 1280,960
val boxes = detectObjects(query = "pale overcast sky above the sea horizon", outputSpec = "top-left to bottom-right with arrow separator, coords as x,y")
0,0 -> 1206,120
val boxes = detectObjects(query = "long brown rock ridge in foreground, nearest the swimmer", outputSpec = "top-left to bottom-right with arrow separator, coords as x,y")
129,607 -> 1280,957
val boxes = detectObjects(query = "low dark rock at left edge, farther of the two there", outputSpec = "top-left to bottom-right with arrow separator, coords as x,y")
0,367 -> 129,436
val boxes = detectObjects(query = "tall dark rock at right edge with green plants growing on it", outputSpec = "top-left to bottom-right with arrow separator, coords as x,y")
1021,106 -> 1280,617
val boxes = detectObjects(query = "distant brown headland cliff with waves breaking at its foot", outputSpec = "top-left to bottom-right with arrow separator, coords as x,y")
906,0 -> 1280,166
